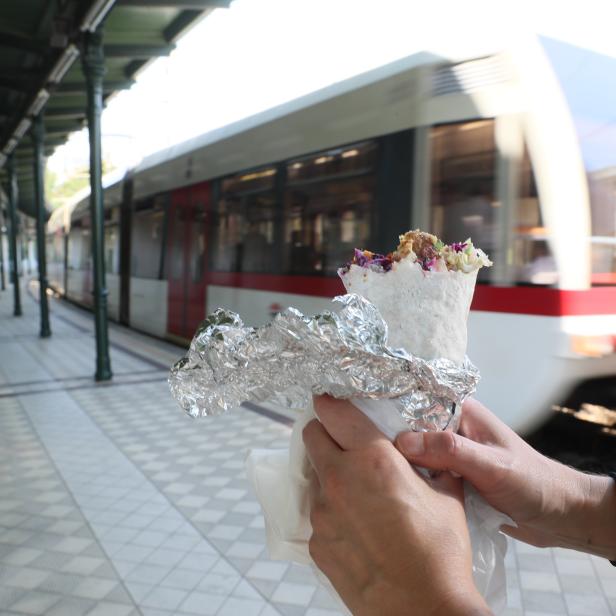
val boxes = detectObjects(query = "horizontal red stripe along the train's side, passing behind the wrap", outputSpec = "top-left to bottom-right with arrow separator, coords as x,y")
207,272 -> 616,316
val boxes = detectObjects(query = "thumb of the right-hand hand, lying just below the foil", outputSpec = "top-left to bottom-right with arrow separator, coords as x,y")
395,431 -> 500,491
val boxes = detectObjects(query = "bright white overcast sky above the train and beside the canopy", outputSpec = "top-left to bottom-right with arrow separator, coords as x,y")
48,0 -> 616,181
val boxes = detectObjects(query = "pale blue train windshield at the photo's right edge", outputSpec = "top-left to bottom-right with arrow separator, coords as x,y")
541,37 -> 616,285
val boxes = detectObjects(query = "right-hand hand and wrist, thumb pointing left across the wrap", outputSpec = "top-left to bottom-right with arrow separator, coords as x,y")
396,399 -> 616,558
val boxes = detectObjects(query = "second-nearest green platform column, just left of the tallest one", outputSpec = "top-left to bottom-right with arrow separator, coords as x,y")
32,112 -> 51,338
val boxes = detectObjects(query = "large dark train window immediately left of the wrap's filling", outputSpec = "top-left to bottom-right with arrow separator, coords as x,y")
283,142 -> 377,275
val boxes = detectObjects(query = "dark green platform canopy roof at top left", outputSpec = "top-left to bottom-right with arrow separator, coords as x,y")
0,0 -> 231,216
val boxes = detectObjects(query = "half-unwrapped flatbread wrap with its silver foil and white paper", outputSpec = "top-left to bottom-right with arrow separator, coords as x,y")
170,230 -> 510,609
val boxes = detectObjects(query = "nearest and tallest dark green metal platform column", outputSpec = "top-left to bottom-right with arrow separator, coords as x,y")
81,30 -> 112,381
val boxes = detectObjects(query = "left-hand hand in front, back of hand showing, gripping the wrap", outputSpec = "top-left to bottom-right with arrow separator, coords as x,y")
303,396 -> 490,616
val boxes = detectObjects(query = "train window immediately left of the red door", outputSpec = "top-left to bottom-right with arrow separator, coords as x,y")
131,199 -> 165,279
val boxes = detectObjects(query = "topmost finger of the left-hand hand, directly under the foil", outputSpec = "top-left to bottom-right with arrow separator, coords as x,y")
314,396 -> 387,451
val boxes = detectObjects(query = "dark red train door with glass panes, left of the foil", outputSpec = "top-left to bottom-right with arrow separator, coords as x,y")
167,184 -> 210,339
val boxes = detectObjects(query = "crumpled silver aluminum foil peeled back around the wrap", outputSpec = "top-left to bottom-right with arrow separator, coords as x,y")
169,294 -> 479,430
